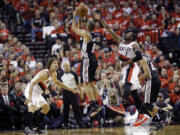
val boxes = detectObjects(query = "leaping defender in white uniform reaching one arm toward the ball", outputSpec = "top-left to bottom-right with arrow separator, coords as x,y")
93,12 -> 148,122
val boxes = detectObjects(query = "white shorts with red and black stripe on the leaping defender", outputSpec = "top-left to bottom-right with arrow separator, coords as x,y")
121,63 -> 141,90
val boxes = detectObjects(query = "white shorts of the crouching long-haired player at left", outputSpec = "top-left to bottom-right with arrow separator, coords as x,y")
25,84 -> 47,110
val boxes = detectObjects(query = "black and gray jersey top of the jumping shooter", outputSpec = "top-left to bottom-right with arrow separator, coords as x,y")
81,32 -> 96,58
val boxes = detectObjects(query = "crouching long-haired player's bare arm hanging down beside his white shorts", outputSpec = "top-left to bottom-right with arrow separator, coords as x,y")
25,70 -> 48,104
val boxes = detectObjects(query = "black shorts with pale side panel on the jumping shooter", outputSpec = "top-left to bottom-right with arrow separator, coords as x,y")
81,55 -> 98,83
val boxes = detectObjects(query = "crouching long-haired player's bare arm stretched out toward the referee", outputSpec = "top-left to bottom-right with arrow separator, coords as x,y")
53,72 -> 77,93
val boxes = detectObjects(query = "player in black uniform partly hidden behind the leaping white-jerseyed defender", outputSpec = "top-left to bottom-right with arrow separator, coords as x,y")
139,55 -> 170,129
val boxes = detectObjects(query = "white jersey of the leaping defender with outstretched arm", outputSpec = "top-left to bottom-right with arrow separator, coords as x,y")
119,41 -> 137,61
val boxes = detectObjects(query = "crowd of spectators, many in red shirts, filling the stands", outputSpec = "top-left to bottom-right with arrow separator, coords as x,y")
0,0 -> 180,129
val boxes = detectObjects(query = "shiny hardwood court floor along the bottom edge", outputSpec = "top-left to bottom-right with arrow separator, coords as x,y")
0,125 -> 180,135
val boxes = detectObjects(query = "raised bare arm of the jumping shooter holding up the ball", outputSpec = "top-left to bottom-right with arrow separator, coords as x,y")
72,11 -> 91,42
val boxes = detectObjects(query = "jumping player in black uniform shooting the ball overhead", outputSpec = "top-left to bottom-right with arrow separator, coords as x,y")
72,11 -> 102,117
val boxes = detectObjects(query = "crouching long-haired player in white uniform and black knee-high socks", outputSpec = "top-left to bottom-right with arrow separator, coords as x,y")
24,57 -> 77,134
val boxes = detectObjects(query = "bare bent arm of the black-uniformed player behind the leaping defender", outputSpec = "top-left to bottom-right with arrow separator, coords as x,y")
139,58 -> 151,81
